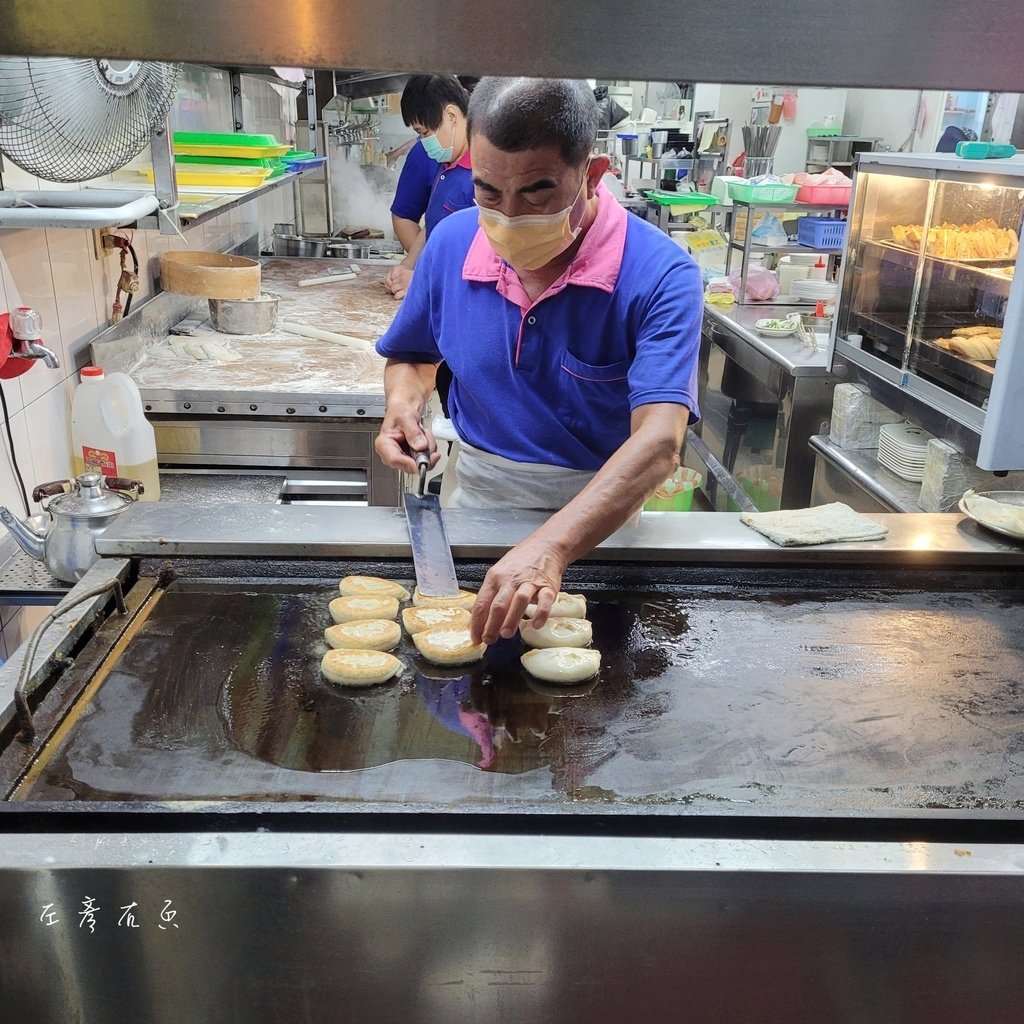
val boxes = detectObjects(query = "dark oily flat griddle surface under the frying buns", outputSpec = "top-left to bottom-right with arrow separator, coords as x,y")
15,581 -> 1024,815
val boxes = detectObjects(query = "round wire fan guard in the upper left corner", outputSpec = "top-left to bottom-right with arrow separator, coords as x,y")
0,57 -> 179,181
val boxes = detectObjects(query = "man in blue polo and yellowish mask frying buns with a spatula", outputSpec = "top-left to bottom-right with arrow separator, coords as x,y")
377,78 -> 703,643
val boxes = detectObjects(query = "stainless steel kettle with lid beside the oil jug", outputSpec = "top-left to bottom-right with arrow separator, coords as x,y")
0,472 -> 143,583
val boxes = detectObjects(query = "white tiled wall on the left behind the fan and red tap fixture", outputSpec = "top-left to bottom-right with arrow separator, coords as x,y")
0,67 -> 295,658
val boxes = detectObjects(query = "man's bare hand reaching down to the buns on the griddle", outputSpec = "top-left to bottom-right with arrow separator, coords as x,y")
470,535 -> 568,644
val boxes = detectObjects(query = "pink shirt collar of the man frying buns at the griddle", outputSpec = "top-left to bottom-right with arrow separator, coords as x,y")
462,183 -> 629,292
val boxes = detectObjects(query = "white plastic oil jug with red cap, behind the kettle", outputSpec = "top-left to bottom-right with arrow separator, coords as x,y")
71,367 -> 160,502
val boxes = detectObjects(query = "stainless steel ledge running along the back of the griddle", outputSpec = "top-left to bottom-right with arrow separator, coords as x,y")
96,503 -> 1024,568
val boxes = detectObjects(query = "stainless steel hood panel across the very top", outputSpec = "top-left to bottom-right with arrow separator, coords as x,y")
0,0 -> 1024,92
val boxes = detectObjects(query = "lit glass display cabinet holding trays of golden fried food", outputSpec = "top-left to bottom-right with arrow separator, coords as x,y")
833,153 -> 1024,470
